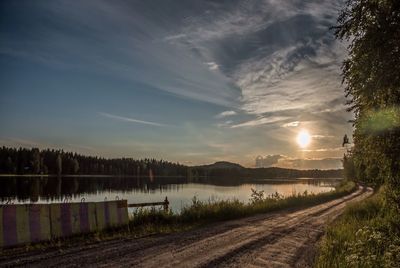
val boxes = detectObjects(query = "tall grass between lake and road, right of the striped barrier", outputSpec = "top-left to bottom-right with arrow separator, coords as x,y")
130,181 -> 355,231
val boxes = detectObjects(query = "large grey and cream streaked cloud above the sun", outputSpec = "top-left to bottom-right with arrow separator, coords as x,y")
172,0 -> 344,122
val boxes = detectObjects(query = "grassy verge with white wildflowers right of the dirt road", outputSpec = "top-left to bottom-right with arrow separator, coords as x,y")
315,188 -> 400,267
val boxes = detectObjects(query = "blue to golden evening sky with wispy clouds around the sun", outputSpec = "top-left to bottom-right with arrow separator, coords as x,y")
0,0 -> 352,168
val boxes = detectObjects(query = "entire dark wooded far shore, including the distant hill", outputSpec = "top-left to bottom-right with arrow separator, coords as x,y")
0,146 -> 342,181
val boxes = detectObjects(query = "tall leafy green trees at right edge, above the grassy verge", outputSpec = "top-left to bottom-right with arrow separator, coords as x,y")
334,0 -> 400,210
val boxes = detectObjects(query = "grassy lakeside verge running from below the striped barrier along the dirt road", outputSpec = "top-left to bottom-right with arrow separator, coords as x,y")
2,182 -> 356,261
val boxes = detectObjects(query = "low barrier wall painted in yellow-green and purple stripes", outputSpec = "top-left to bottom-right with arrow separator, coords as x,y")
0,200 -> 128,247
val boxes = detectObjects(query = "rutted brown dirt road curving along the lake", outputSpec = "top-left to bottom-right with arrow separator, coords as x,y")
0,187 -> 372,267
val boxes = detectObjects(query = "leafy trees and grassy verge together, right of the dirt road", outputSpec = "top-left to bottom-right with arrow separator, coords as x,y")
316,0 -> 400,267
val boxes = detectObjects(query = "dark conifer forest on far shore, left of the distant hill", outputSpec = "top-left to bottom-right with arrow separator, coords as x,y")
0,146 -> 187,176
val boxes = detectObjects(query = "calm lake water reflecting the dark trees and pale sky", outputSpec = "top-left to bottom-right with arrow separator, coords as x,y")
0,177 -> 339,211
